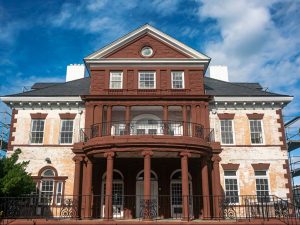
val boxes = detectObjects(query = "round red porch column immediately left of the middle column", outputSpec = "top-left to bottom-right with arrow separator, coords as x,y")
104,152 -> 115,220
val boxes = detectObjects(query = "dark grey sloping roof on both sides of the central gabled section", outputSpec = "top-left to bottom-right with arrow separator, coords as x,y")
7,77 -> 288,97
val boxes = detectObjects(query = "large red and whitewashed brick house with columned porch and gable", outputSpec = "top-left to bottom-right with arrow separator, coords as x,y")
1,25 -> 292,220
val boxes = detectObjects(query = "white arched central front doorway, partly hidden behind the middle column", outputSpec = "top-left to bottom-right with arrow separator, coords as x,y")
135,170 -> 158,218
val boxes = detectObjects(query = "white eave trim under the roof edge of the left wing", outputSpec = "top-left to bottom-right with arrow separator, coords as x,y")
0,96 -> 82,102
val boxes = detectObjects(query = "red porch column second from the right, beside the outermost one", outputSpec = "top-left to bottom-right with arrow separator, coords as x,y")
201,157 -> 210,219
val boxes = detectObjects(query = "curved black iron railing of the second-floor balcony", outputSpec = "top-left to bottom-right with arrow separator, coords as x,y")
80,120 -> 214,142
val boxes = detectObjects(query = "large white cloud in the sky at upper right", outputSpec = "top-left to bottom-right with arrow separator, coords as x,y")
198,0 -> 300,116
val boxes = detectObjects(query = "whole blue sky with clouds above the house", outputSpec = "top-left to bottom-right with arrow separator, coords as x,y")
0,0 -> 300,134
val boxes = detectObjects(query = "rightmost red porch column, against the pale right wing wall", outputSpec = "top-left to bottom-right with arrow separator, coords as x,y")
211,154 -> 222,218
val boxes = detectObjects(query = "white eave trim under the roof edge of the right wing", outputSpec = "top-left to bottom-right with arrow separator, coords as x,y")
214,96 -> 294,102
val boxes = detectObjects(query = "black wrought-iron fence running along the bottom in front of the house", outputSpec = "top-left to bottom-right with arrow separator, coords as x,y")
0,195 -> 300,224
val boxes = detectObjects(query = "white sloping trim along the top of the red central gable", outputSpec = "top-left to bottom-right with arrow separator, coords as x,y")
84,24 -> 210,61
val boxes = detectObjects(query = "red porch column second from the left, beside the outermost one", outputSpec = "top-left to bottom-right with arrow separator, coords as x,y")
82,157 -> 93,218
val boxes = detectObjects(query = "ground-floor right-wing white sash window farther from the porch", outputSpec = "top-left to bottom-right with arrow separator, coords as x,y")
255,170 -> 270,202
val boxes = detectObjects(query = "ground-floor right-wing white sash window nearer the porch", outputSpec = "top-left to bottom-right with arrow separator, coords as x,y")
224,170 -> 239,203
